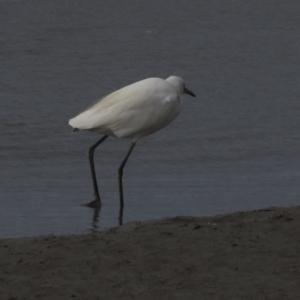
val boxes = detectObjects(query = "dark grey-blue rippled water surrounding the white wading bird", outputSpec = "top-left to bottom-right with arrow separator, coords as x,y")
0,0 -> 300,237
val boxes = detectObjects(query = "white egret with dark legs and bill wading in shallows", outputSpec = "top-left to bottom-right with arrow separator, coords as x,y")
69,76 -> 196,209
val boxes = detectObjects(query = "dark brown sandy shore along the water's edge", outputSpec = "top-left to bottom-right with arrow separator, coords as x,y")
0,207 -> 300,300
